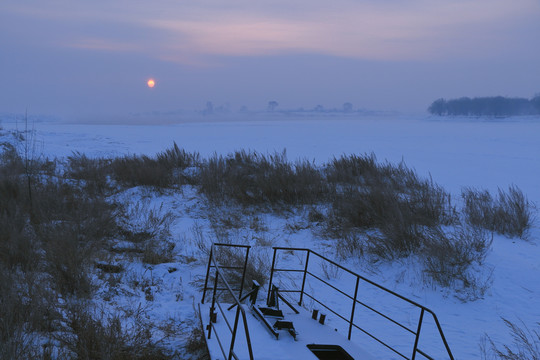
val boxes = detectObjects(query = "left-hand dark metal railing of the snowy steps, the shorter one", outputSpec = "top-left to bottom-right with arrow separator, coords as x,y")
201,243 -> 253,360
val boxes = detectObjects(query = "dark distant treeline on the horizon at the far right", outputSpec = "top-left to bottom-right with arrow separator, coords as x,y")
428,95 -> 540,116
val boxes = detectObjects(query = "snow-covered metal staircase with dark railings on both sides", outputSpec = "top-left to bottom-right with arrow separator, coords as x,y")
199,243 -> 454,360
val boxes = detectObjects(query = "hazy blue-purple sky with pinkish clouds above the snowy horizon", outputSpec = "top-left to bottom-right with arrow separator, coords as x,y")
0,0 -> 540,116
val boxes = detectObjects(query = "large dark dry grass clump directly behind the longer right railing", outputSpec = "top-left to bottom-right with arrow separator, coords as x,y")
326,155 -> 456,259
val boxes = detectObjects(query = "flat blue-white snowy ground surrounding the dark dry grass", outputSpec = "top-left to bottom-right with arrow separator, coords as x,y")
0,116 -> 540,359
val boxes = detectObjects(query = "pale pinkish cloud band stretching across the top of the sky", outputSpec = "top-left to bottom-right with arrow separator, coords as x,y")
7,0 -> 540,62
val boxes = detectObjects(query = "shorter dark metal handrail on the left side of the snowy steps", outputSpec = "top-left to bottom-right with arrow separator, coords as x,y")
201,243 -> 254,360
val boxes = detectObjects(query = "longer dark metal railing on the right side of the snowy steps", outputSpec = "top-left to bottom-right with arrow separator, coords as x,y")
268,247 -> 454,360
